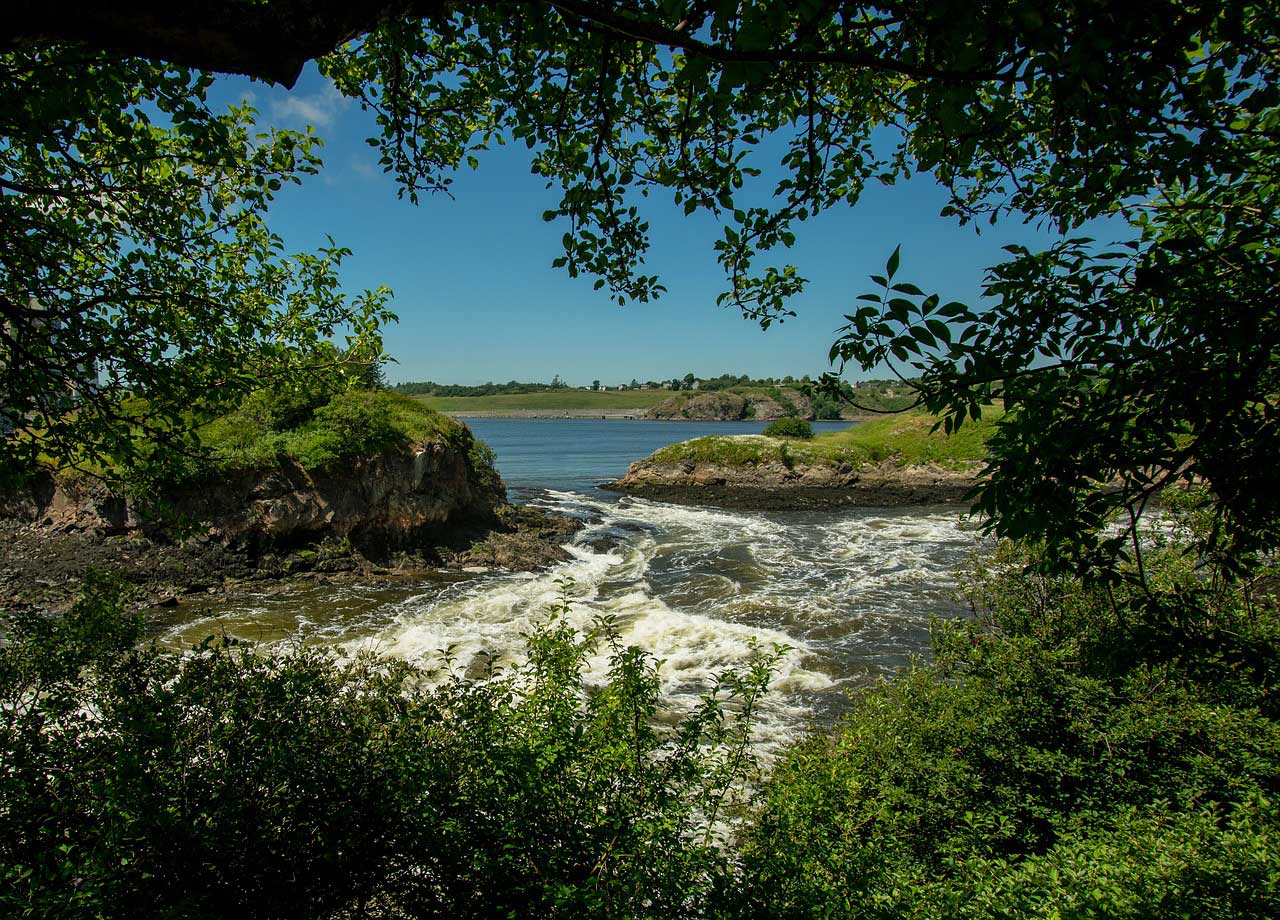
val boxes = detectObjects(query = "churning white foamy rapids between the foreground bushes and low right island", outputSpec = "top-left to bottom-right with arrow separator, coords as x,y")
351,491 -> 972,754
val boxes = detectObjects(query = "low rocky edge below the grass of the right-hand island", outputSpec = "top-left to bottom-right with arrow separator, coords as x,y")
603,440 -> 982,511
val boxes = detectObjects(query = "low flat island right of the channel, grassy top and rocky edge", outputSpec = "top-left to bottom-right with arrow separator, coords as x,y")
605,408 -> 1001,509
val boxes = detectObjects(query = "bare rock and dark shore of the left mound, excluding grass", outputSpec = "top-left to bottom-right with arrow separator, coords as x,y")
0,391 -> 581,607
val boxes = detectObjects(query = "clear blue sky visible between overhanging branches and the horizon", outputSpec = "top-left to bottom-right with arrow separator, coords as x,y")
218,72 -> 1070,385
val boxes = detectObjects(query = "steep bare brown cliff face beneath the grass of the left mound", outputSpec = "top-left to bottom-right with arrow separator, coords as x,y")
0,443 -> 506,546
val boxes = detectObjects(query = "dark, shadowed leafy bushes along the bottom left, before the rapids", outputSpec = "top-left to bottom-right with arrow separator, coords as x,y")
0,581 -> 772,920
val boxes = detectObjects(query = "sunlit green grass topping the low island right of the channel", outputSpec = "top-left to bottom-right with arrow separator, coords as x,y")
653,408 -> 1004,467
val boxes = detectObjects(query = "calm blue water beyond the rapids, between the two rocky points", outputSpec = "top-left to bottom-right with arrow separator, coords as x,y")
462,418 -> 855,500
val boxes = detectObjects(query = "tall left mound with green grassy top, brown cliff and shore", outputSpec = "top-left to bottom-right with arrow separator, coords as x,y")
0,388 -> 579,605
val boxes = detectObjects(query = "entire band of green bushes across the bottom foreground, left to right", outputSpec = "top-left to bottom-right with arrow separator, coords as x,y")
0,495 -> 1280,920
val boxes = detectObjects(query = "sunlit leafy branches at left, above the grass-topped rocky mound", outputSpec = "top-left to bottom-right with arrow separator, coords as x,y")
0,47 -> 393,481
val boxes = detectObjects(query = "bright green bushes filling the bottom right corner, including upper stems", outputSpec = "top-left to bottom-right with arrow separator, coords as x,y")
741,516 -> 1280,920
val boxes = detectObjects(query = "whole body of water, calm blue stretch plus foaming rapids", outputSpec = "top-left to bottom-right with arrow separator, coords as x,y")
168,420 -> 974,747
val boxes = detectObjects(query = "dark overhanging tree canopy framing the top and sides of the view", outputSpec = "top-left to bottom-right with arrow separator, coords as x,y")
0,0 -> 1280,575
